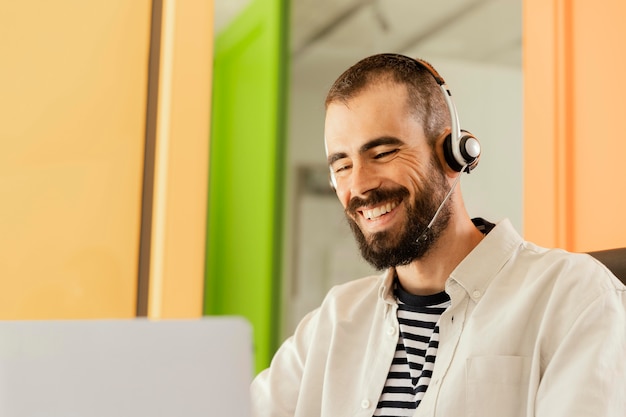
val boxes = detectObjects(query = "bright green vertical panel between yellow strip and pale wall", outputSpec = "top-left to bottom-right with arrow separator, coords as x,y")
205,0 -> 288,370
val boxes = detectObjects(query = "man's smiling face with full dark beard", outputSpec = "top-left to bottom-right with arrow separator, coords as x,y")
325,83 -> 450,269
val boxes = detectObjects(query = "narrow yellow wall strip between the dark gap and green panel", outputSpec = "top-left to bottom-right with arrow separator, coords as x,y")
148,0 -> 213,318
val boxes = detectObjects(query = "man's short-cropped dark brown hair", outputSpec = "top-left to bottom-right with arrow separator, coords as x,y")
325,54 -> 450,145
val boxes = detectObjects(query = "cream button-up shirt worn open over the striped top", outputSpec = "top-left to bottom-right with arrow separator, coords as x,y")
251,220 -> 626,417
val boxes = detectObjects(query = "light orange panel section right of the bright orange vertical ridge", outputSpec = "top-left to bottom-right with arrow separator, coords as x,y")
572,0 -> 626,250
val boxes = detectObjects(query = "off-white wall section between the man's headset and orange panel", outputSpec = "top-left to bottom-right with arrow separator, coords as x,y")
432,56 -> 523,228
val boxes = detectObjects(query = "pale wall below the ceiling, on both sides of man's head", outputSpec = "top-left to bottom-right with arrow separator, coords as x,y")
283,55 -> 523,335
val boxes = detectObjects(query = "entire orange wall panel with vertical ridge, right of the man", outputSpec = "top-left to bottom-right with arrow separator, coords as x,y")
523,0 -> 626,251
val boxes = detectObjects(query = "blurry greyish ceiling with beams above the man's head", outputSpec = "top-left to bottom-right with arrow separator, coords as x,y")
215,0 -> 522,83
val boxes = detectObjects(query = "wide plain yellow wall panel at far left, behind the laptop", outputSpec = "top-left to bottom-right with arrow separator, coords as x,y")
0,0 -> 151,319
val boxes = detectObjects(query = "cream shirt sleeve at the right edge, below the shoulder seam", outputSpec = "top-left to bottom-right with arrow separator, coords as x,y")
534,287 -> 626,417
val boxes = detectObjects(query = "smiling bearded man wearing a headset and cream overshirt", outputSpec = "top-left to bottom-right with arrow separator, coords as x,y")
251,54 -> 626,417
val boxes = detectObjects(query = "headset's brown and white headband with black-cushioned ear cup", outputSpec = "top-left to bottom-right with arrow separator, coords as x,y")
412,58 -> 480,173
